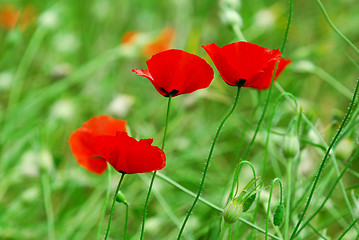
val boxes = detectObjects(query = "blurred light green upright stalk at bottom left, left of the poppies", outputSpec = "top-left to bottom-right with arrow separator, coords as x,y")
41,173 -> 55,240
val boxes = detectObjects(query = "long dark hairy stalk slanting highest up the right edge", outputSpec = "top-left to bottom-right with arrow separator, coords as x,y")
290,80 -> 359,239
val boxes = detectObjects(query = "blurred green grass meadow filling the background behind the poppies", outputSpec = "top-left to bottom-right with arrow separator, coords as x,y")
0,0 -> 359,240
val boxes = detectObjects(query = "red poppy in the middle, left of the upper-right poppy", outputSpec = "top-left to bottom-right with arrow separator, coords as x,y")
132,49 -> 213,97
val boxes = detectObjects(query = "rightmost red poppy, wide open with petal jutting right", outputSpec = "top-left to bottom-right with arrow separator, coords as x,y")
202,42 -> 291,90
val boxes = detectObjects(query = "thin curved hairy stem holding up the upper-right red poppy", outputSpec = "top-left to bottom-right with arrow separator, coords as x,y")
177,85 -> 242,239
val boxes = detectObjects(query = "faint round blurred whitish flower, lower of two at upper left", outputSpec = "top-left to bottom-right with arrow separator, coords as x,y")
53,33 -> 80,53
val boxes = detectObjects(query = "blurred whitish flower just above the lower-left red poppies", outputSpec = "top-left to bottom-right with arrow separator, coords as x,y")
107,94 -> 135,117
